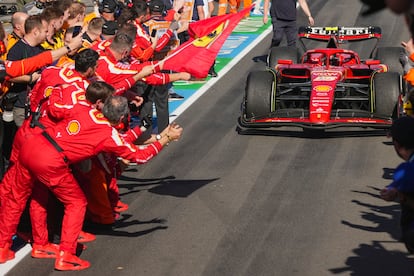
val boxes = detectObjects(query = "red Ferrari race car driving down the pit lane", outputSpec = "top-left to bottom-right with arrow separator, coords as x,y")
239,27 -> 405,129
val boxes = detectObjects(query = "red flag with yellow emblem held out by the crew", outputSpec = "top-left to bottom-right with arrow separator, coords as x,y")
163,6 -> 252,78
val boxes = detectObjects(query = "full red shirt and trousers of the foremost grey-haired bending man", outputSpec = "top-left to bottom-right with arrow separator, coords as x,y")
0,94 -> 162,264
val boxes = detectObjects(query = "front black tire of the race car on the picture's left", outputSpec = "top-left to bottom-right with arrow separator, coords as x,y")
243,71 -> 274,120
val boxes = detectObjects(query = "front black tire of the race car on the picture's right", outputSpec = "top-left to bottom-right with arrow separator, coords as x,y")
371,72 -> 402,118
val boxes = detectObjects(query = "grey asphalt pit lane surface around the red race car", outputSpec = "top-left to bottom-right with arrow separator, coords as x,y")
4,0 -> 414,276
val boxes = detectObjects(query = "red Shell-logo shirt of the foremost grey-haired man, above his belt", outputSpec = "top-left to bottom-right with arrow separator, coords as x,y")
46,94 -> 162,164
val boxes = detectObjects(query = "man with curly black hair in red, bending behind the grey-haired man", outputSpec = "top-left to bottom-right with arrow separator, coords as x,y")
2,49 -> 98,258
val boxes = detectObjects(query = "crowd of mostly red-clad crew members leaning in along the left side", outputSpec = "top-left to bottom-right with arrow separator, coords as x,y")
0,0 -> 215,270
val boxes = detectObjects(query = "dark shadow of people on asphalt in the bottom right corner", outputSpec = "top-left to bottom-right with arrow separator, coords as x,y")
329,187 -> 414,276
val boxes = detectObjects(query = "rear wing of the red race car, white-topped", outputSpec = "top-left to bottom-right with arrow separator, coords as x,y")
298,26 -> 382,55
